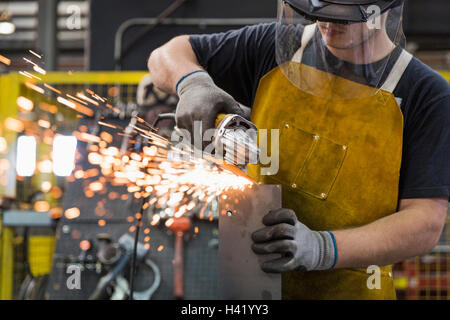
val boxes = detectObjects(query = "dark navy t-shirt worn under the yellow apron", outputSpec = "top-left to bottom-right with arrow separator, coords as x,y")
190,23 -> 450,199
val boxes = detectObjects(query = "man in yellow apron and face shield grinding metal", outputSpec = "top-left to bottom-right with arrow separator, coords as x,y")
148,0 -> 450,299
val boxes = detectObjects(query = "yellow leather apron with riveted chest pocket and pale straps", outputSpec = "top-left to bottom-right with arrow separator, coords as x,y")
247,25 -> 411,299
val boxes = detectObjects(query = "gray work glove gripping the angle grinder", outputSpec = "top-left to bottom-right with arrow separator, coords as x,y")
176,72 -> 244,147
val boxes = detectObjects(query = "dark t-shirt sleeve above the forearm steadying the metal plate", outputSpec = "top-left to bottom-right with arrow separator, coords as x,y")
400,61 -> 450,198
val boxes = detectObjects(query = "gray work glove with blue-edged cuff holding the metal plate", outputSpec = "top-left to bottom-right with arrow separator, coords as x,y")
252,209 -> 337,273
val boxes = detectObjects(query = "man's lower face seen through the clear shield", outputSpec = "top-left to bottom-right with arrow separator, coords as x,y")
317,21 -> 377,49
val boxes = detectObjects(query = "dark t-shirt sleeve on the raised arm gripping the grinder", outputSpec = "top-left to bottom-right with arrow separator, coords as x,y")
189,23 -> 275,107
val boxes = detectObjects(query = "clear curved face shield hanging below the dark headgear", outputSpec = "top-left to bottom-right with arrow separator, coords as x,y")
276,0 -> 405,99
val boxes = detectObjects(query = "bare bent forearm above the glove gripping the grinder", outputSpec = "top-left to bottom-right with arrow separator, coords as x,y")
148,36 -> 203,93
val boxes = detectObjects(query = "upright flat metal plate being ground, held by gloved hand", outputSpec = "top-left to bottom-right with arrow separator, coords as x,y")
218,185 -> 281,300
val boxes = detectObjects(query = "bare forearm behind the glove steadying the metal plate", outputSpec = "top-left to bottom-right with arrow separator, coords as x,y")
333,199 -> 448,268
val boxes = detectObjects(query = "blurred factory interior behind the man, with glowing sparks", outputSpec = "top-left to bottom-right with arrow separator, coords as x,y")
0,0 -> 450,300
